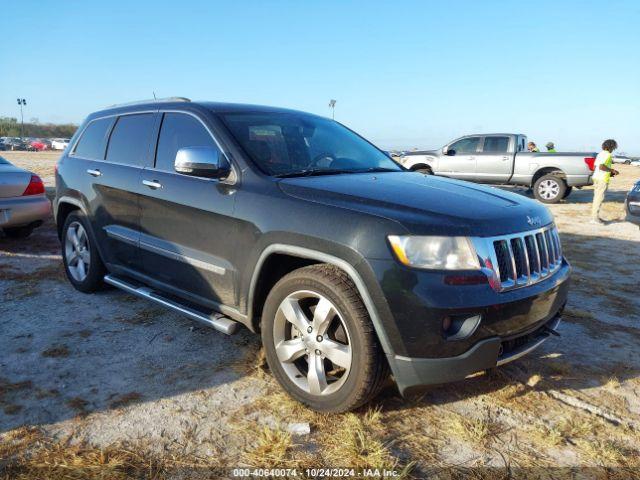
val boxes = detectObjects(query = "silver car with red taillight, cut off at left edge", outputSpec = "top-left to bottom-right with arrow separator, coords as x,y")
0,157 -> 51,238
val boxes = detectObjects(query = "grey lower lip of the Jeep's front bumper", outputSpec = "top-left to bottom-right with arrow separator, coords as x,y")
388,315 -> 560,395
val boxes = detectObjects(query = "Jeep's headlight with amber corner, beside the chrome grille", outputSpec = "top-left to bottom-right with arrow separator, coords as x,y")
388,235 -> 480,270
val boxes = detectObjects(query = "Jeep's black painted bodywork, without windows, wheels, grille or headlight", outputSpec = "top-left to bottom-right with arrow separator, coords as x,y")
54,102 -> 570,390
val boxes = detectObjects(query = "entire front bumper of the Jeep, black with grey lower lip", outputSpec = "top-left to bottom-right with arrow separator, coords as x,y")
369,258 -> 571,392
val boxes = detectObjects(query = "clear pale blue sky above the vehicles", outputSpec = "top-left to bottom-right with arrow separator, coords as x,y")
0,0 -> 640,155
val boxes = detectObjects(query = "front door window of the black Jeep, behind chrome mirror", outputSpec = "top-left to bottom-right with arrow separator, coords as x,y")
156,113 -> 216,172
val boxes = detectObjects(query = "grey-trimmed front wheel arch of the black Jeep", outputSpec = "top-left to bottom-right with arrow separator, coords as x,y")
247,244 -> 393,355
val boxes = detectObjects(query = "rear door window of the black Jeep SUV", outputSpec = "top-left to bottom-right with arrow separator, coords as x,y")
107,113 -> 153,166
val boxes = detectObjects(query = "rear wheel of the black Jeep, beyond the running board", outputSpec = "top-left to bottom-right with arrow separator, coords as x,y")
62,212 -> 106,293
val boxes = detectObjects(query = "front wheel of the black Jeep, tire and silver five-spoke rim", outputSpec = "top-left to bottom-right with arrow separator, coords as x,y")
261,265 -> 388,413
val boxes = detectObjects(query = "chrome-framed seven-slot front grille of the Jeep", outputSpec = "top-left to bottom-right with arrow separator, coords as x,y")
473,225 -> 562,291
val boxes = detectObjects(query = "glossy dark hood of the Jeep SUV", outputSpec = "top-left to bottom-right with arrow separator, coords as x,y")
279,172 -> 553,236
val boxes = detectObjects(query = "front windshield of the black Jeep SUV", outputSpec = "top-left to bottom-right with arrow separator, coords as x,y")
222,113 -> 402,177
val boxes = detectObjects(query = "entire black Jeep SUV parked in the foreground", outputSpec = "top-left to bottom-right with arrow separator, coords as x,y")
54,99 -> 570,412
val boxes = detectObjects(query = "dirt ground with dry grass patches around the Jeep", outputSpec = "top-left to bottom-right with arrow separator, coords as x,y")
0,152 -> 640,478
